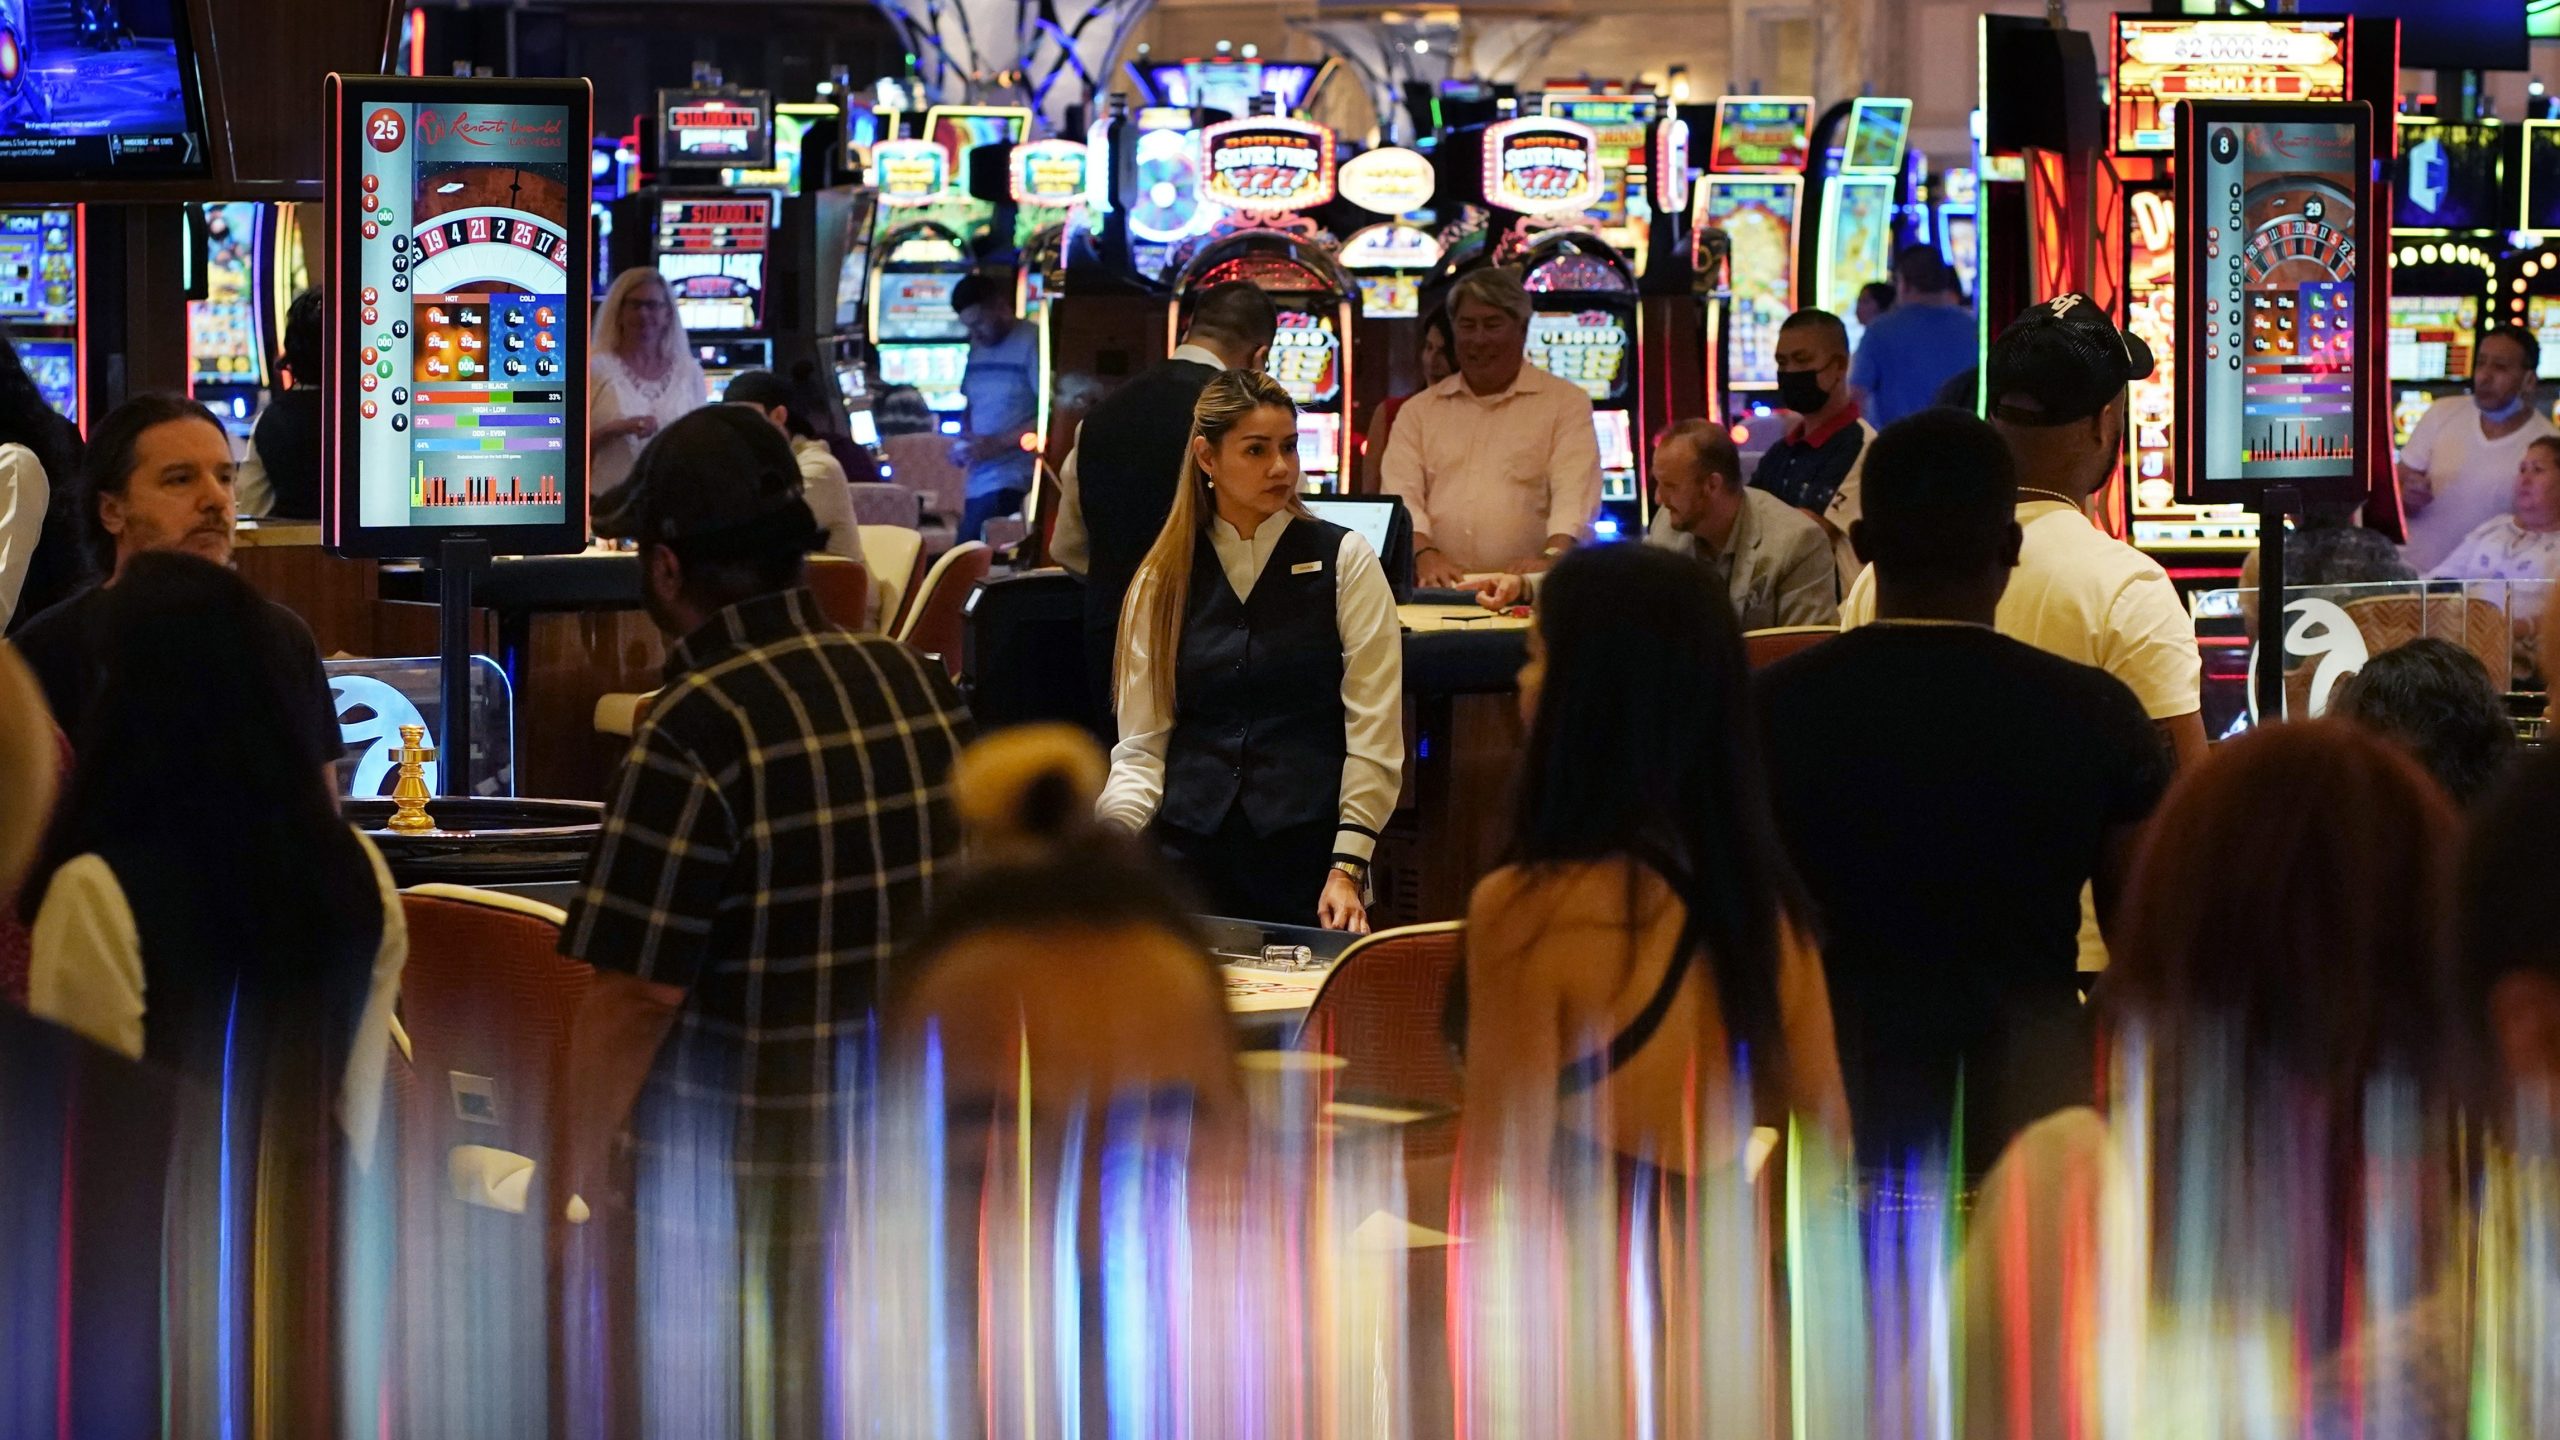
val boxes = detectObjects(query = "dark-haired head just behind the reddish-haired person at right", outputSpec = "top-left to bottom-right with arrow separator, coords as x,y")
2330,635 -> 2508,809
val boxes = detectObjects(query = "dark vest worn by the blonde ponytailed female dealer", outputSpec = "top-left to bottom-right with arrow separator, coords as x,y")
1162,520 -> 1349,835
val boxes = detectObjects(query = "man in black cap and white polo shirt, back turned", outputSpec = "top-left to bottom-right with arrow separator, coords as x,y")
1841,295 -> 2204,971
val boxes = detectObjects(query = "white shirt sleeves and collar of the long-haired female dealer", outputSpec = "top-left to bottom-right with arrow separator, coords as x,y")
1096,510 -> 1405,861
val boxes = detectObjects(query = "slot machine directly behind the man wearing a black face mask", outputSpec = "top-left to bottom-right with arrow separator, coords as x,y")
1692,95 -> 1812,420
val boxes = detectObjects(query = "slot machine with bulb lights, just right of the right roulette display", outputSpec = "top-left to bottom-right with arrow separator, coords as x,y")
2383,115 -> 2522,446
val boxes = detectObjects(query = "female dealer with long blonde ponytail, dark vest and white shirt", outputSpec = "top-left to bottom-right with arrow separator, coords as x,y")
1101,372 -> 1405,933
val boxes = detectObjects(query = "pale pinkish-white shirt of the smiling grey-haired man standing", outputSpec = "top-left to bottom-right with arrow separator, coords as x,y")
1377,364 -> 1600,574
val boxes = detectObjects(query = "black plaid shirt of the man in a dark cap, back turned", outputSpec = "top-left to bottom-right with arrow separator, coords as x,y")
561,589 -> 970,1174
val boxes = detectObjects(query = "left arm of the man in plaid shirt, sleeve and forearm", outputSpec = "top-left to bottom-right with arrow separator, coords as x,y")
561,723 -> 737,1197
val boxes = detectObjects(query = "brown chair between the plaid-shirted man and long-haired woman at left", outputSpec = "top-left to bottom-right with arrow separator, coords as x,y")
389,884 -> 594,1435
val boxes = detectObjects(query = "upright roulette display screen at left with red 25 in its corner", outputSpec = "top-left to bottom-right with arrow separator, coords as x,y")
328,74 -> 594,556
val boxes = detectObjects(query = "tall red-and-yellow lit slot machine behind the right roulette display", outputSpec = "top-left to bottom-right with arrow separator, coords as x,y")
2109,15 -> 2353,566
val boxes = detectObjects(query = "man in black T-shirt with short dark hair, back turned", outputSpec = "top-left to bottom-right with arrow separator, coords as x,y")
1759,410 -> 2168,1174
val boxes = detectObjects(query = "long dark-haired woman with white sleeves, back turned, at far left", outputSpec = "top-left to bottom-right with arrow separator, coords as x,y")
20,553 -> 407,1435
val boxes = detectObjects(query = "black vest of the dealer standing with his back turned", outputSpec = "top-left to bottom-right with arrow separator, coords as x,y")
1075,361 -> 1219,623
